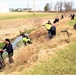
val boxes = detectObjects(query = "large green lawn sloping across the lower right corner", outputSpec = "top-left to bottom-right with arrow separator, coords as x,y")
20,42 -> 76,75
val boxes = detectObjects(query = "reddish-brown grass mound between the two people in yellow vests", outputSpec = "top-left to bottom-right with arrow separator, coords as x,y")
29,27 -> 48,42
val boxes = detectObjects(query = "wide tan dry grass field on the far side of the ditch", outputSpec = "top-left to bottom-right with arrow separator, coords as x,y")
0,18 -> 52,42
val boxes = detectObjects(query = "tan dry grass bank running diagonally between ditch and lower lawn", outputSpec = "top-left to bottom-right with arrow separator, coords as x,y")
0,14 -> 76,75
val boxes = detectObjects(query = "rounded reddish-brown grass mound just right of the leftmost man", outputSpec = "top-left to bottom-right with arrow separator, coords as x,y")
15,45 -> 37,65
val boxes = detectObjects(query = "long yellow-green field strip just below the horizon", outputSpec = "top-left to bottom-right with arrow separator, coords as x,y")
0,12 -> 60,20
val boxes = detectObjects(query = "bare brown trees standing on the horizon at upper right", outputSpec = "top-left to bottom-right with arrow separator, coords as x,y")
44,1 -> 76,12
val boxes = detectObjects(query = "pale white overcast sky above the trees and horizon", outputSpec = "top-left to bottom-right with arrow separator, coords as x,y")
0,0 -> 76,10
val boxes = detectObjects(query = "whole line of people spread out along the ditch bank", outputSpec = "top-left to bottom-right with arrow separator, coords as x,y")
0,14 -> 76,68
